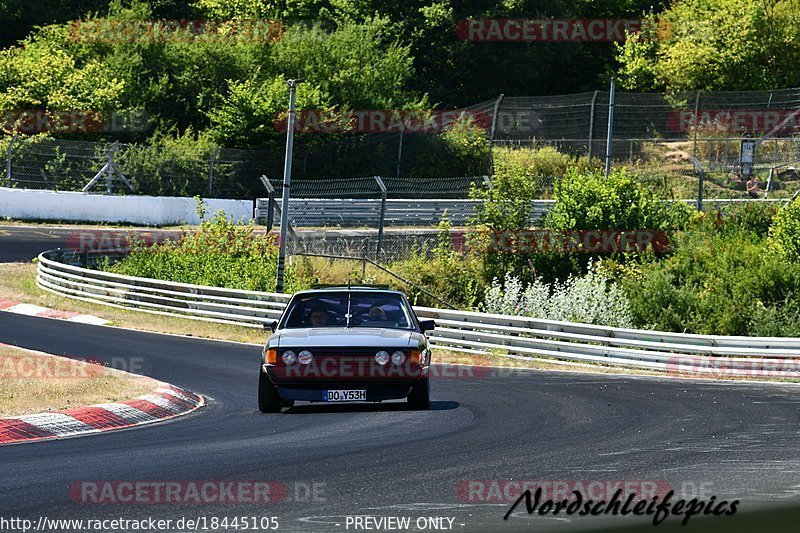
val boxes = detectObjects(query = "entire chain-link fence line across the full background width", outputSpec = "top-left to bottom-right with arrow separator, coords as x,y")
0,89 -> 800,199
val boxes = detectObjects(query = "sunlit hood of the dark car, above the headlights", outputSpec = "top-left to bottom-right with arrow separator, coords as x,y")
267,328 -> 425,348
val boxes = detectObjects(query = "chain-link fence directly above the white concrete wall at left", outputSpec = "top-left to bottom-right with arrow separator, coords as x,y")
0,137 -> 283,198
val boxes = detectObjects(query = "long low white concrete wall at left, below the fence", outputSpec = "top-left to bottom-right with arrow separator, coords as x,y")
0,187 -> 253,226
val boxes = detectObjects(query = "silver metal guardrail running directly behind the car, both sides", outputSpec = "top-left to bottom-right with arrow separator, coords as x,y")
36,250 -> 800,379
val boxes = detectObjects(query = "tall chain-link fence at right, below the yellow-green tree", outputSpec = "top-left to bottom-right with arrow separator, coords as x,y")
493,89 -> 800,198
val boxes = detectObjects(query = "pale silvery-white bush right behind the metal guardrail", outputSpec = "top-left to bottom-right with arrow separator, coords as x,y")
482,267 -> 633,327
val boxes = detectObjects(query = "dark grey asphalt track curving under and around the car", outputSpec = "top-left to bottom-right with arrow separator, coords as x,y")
0,313 -> 800,531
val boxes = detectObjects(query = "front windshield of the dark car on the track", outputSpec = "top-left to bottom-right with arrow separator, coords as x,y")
283,293 -> 413,329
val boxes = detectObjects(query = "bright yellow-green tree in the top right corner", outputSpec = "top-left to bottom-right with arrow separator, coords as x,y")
618,0 -> 800,92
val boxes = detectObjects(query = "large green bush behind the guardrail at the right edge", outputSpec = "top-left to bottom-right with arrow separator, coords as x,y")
622,231 -> 800,335
